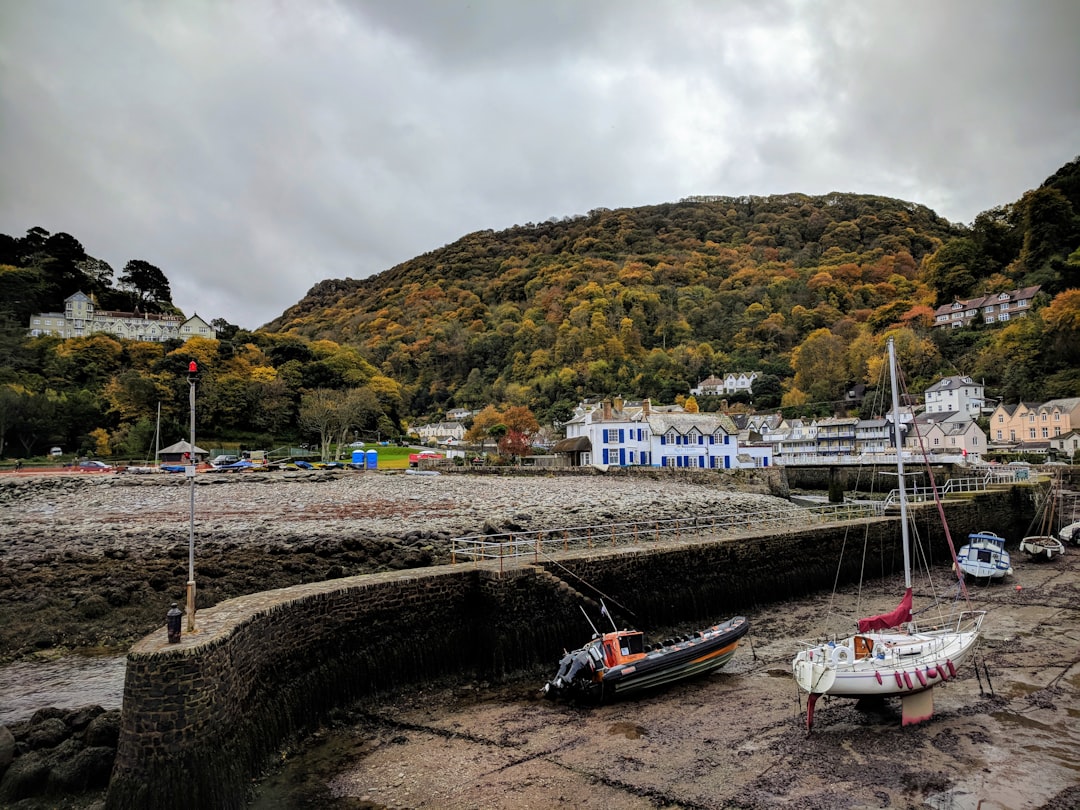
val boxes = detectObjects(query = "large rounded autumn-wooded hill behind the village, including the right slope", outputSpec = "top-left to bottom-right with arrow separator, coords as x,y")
265,161 -> 1080,420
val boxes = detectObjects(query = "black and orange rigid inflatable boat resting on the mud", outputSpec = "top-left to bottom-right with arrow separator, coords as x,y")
543,609 -> 750,702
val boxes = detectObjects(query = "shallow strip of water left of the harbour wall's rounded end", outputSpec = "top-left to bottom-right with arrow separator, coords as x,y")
0,656 -> 126,725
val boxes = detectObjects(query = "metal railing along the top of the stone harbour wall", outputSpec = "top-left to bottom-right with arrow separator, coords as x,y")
450,501 -> 885,570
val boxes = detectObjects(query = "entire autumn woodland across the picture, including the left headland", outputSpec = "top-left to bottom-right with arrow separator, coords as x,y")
0,160 -> 1080,457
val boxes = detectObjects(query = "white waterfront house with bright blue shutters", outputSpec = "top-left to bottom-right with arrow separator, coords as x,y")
552,400 -> 772,470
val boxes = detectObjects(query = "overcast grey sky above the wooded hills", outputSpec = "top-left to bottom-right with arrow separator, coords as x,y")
0,0 -> 1080,328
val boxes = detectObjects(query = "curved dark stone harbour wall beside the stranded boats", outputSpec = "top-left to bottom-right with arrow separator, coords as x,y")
107,488 -> 1031,810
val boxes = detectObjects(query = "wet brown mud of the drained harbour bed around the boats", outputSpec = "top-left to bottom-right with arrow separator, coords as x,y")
252,546 -> 1080,810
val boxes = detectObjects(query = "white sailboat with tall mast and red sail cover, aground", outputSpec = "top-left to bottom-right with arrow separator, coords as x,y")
792,339 -> 986,729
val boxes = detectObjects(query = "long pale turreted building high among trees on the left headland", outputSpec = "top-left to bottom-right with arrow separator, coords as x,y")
29,293 -> 217,343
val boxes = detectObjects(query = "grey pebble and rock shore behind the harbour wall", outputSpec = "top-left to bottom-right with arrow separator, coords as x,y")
0,471 -> 791,663
